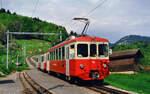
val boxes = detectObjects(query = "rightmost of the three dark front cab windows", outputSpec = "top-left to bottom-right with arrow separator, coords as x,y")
98,44 -> 108,56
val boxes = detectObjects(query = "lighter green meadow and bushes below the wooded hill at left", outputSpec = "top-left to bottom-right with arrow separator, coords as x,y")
0,39 -> 50,77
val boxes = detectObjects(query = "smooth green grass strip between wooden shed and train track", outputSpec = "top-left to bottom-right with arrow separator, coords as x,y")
105,73 -> 150,94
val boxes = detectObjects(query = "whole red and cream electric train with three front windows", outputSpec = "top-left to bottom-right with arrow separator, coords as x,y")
37,36 -> 109,80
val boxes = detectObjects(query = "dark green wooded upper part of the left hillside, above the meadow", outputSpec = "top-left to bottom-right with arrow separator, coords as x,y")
0,9 -> 68,44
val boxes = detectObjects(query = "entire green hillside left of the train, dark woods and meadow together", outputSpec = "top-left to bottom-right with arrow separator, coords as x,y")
0,9 -> 68,77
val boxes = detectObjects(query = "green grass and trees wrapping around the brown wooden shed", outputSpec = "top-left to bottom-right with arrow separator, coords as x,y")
108,42 -> 150,94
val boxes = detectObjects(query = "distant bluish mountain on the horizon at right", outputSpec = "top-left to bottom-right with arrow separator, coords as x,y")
115,35 -> 150,45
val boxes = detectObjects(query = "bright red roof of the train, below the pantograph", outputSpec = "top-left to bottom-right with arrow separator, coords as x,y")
46,36 -> 108,52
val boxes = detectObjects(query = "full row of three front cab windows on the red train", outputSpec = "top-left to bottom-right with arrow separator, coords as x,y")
77,44 -> 108,58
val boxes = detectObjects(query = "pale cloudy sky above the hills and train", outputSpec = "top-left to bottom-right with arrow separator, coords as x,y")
1,0 -> 150,43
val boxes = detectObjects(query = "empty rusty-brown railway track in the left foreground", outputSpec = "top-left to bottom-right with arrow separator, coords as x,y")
19,72 -> 52,94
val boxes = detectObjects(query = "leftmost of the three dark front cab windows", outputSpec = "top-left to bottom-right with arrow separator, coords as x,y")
77,44 -> 88,57
